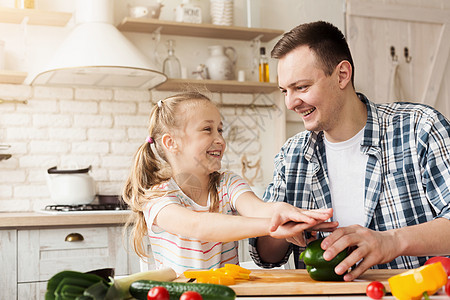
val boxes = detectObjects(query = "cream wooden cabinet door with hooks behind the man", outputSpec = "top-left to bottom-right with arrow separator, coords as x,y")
346,0 -> 450,117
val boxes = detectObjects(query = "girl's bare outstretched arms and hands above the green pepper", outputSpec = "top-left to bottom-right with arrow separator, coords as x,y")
154,192 -> 332,242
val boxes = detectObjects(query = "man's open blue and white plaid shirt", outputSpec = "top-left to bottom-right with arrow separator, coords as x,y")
250,94 -> 450,269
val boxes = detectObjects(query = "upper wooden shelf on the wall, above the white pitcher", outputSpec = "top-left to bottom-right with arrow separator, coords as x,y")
117,17 -> 283,42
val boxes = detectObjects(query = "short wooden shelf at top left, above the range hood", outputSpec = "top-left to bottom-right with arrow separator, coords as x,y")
0,7 -> 72,26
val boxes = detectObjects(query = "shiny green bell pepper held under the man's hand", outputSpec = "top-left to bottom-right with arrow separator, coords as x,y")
300,238 -> 348,281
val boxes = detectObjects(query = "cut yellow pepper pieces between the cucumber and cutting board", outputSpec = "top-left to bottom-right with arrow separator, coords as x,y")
183,264 -> 251,285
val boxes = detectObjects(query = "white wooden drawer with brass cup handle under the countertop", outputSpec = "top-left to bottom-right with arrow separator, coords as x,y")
17,226 -> 128,283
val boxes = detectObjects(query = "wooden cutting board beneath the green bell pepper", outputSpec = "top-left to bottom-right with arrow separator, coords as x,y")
176,269 -> 406,296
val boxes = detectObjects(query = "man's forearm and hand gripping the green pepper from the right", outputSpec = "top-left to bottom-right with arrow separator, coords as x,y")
321,218 -> 450,281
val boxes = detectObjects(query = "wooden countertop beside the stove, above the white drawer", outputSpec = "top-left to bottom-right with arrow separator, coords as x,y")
0,210 -> 130,229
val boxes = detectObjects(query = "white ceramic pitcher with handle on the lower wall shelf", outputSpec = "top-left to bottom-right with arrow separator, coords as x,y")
206,45 -> 237,80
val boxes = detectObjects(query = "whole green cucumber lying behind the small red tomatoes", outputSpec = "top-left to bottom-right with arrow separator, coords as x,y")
130,280 -> 236,300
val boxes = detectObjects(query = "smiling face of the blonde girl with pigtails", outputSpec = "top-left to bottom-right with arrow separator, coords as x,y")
171,100 -> 226,176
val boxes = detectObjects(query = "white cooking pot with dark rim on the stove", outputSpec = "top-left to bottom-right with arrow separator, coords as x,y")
47,166 -> 96,205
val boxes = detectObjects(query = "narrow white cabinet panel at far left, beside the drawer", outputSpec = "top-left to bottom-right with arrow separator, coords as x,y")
0,230 -> 17,299
